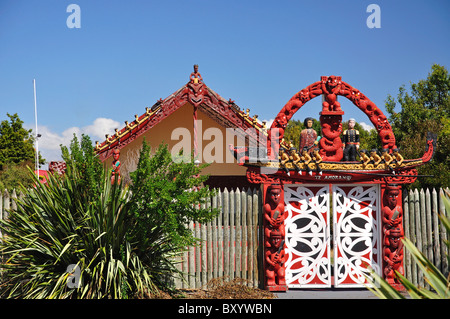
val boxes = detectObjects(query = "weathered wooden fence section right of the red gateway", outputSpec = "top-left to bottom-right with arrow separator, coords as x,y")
403,188 -> 450,287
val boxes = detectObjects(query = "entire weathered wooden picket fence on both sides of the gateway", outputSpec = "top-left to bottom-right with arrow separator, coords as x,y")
0,188 -> 450,288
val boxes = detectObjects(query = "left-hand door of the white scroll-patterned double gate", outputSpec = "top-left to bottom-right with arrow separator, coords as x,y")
284,185 -> 331,288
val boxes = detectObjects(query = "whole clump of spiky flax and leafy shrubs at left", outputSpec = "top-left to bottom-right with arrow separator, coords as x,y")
0,137 -> 218,298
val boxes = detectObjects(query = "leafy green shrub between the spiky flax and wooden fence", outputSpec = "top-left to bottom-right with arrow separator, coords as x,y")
127,140 -> 218,251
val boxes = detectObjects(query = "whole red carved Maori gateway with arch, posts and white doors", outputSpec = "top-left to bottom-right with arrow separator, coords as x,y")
234,76 -> 436,291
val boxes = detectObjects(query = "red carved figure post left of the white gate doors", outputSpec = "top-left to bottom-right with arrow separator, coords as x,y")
263,184 -> 287,291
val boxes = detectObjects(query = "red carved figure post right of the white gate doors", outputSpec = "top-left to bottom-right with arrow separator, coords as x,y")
382,184 -> 404,286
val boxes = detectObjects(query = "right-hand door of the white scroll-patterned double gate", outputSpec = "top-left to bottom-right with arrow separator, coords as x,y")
333,185 -> 381,288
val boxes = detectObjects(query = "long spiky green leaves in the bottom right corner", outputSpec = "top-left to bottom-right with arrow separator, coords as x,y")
369,194 -> 450,299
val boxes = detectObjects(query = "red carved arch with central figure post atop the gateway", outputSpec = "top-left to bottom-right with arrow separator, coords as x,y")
268,75 -> 396,161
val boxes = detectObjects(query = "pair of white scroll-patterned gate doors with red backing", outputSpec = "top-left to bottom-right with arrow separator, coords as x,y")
284,185 -> 381,288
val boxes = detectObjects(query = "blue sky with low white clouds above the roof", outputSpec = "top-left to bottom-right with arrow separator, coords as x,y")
0,0 -> 450,168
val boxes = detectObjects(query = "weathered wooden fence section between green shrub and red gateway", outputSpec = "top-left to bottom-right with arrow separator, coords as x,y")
175,189 -> 262,288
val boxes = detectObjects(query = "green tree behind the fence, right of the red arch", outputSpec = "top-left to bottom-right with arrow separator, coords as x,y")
386,64 -> 450,187
